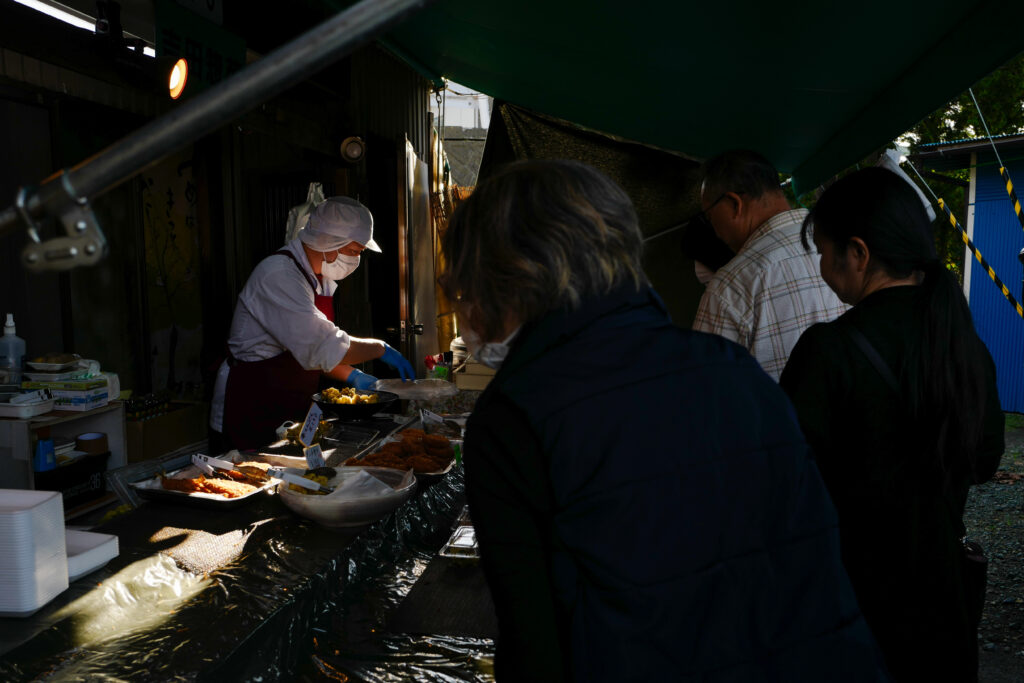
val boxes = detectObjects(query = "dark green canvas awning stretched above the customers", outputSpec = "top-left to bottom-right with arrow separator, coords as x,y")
368,0 -> 1024,190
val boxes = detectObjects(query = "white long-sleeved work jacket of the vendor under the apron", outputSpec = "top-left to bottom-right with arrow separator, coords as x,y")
210,238 -> 351,431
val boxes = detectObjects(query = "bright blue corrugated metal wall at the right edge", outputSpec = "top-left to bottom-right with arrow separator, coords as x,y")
969,155 -> 1024,413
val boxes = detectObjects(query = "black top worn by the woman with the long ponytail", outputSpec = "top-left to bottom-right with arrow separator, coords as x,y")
779,287 -> 1004,683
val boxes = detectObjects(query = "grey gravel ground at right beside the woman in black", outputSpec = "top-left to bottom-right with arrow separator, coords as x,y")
964,414 -> 1024,683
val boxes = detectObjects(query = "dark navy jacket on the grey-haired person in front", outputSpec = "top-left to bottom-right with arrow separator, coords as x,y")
465,290 -> 886,683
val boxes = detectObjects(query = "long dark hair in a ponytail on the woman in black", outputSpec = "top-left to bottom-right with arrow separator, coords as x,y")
801,168 -> 987,474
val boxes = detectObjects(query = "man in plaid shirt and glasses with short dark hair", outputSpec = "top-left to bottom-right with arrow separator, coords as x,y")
693,150 -> 847,380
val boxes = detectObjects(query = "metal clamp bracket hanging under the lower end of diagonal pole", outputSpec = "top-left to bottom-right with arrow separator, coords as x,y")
14,172 -> 108,272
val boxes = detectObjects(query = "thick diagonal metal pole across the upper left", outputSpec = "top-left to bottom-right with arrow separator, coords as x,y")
0,0 -> 434,236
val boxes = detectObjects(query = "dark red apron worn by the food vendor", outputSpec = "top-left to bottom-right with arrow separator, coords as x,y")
223,250 -> 334,450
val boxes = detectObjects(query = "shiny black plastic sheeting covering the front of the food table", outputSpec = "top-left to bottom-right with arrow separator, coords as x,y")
0,468 -> 494,682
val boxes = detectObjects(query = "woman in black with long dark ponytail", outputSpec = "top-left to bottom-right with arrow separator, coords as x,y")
779,168 -> 1004,683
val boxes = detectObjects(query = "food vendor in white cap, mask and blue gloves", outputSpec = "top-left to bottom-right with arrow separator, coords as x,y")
210,197 -> 415,450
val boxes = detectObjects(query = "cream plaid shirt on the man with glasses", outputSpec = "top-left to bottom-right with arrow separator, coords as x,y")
693,209 -> 848,382
